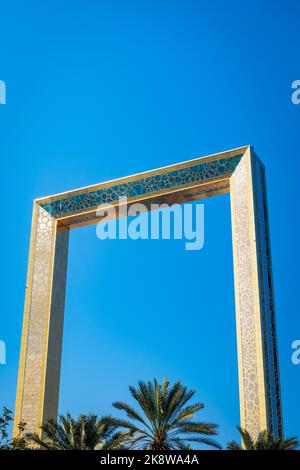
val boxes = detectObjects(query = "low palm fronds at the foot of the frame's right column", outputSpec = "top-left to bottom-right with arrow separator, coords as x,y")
227,426 -> 298,450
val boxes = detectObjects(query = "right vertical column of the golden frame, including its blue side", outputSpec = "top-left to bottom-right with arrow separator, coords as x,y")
230,148 -> 282,437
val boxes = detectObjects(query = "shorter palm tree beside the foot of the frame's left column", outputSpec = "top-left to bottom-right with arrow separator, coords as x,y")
27,413 -> 128,450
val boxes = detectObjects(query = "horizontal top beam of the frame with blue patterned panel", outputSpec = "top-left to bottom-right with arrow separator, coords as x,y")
35,146 -> 249,225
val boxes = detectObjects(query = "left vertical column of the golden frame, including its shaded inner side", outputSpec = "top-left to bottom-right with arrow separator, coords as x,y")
14,204 -> 69,435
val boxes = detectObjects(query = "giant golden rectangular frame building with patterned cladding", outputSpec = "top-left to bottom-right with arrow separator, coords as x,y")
14,146 -> 283,437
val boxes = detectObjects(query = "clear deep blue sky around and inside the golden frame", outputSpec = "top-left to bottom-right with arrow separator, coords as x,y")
0,0 -> 300,443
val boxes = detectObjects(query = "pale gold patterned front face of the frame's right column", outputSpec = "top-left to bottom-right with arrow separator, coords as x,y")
231,151 -> 267,435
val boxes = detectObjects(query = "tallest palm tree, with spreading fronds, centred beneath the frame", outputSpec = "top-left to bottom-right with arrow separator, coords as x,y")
109,379 -> 221,451
